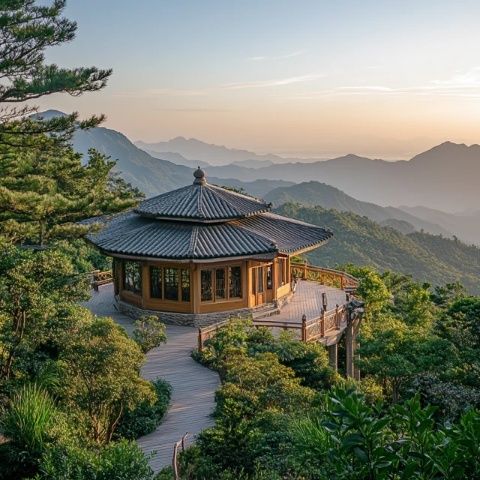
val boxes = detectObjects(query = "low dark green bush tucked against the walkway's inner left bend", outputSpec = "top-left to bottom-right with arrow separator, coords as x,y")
115,378 -> 172,440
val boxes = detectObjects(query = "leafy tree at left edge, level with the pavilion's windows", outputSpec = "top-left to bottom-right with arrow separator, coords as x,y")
0,237 -> 88,387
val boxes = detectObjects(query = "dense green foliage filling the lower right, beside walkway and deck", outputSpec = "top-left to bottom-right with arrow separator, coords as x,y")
172,267 -> 480,480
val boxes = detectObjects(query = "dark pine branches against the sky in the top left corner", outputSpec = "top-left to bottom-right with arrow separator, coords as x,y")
0,0 -> 111,142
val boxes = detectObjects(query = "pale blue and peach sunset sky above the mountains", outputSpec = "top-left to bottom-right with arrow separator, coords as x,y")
39,0 -> 480,159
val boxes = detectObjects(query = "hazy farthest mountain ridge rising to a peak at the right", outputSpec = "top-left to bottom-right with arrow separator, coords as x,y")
150,139 -> 480,212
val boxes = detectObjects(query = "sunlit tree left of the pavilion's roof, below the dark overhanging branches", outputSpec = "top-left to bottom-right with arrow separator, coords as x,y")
0,136 -> 139,246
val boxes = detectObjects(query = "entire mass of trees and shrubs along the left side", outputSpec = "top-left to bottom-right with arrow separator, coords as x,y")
0,0 -> 169,480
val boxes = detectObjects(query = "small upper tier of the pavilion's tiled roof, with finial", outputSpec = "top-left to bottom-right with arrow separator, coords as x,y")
135,167 -> 271,223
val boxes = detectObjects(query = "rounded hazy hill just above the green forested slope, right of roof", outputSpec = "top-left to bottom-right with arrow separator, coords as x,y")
265,181 -> 453,237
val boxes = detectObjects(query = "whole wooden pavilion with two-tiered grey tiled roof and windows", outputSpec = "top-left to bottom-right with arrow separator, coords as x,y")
88,168 -> 332,326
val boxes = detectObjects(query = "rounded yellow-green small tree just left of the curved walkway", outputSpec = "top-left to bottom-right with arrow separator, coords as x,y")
60,318 -> 156,444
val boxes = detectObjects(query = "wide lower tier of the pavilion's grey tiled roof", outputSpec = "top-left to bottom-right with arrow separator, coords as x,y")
87,211 -> 333,261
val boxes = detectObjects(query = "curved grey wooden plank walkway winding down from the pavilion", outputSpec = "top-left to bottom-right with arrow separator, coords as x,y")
85,285 -> 220,472
